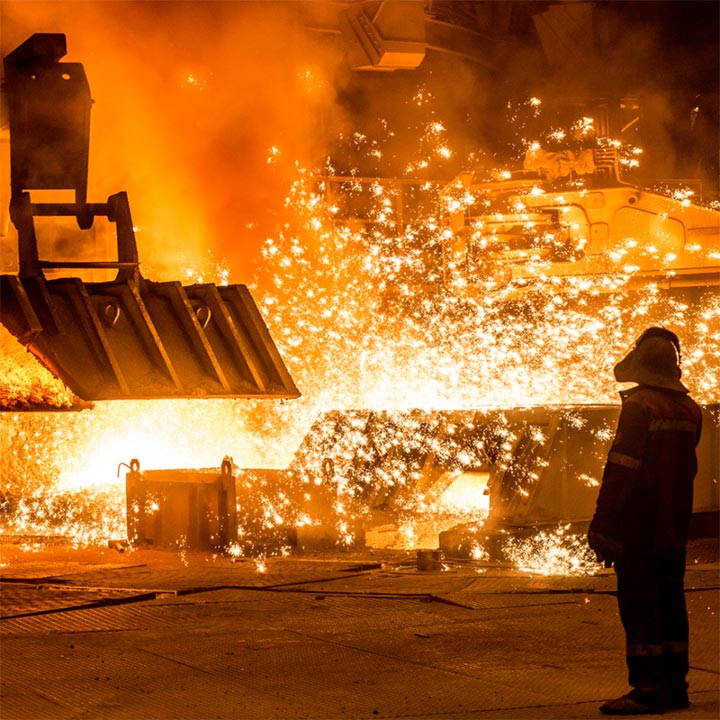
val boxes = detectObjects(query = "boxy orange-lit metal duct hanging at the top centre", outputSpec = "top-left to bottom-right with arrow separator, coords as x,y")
340,0 -> 426,71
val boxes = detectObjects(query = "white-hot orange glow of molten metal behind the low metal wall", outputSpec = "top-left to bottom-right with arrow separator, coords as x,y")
2,162 -> 720,572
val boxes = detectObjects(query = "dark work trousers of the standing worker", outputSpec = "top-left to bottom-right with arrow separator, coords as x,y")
615,552 -> 689,705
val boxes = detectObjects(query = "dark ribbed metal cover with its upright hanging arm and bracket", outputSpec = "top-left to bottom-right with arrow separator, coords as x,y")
0,33 -> 299,401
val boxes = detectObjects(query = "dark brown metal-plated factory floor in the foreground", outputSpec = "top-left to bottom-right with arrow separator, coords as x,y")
0,538 -> 720,720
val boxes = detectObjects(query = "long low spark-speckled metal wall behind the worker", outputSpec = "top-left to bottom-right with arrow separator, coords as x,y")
236,405 -> 720,555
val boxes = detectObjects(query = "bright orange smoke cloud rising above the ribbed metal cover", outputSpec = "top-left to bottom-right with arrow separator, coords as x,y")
1,1 -> 344,280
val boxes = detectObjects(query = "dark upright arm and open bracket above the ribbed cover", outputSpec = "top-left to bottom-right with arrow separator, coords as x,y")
4,33 -> 140,280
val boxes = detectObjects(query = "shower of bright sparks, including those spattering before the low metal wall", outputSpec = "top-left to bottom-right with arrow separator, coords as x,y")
0,102 -> 720,574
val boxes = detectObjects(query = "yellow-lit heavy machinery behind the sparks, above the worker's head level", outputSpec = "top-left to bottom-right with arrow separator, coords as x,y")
443,148 -> 720,292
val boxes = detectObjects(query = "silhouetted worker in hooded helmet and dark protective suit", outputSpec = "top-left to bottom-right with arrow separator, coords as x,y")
588,327 -> 702,715
